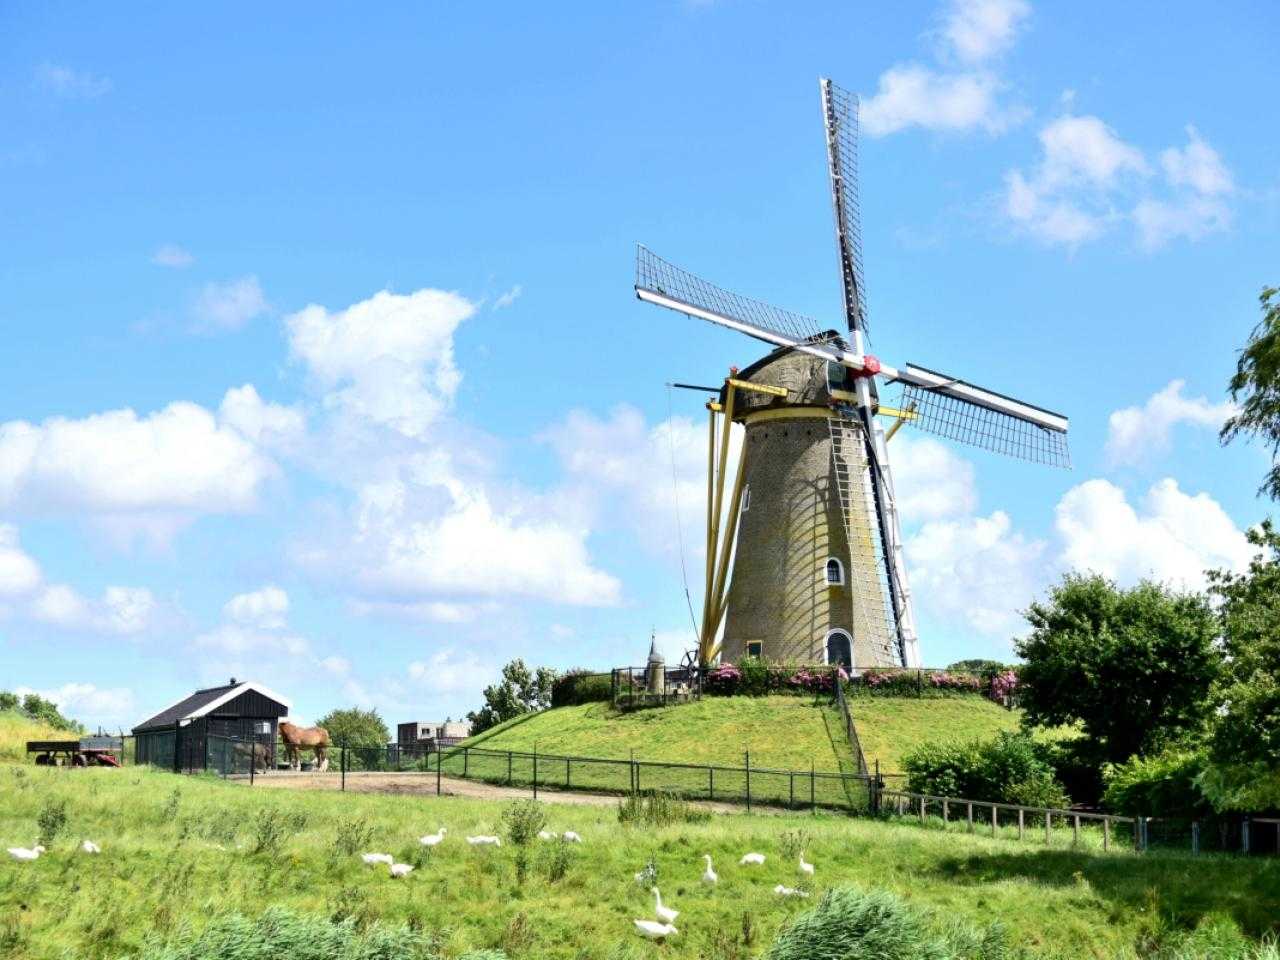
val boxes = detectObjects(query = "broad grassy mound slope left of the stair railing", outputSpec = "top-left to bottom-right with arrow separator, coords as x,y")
467,696 -> 851,771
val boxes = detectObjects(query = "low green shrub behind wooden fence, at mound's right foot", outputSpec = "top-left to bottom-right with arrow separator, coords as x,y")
902,733 -> 1068,806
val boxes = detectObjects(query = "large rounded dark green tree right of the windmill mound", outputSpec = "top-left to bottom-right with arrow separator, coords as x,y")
1016,573 -> 1221,763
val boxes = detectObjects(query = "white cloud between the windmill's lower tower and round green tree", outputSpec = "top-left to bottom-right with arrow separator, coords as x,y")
904,511 -> 1046,640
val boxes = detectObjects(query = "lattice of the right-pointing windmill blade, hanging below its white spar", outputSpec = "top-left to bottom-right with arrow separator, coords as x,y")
899,384 -> 1071,468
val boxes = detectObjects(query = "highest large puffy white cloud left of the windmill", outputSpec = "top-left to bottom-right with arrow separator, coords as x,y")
285,289 -> 475,436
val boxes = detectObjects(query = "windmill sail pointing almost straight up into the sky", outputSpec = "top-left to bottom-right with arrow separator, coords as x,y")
822,79 -> 867,348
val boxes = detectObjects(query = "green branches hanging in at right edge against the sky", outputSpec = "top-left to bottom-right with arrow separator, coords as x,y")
1221,287 -> 1280,499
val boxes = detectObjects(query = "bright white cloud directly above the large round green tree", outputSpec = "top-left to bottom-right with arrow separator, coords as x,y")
1055,477 -> 1253,590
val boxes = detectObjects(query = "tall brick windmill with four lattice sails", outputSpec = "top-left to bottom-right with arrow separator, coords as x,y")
635,79 -> 1070,669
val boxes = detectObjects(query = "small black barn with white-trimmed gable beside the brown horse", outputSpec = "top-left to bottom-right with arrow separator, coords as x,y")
133,677 -> 293,772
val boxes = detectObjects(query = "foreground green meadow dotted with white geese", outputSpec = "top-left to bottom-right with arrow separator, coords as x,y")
0,765 -> 1280,960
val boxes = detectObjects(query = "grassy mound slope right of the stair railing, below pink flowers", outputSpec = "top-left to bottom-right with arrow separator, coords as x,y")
849,696 -> 1021,773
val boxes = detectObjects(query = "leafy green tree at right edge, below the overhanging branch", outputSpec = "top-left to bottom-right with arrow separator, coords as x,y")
1210,520 -> 1280,806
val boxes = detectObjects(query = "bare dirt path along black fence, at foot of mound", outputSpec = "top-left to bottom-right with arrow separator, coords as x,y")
240,771 -> 797,815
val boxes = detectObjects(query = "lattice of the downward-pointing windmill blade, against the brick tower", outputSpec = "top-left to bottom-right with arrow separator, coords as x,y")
827,416 -> 902,667
